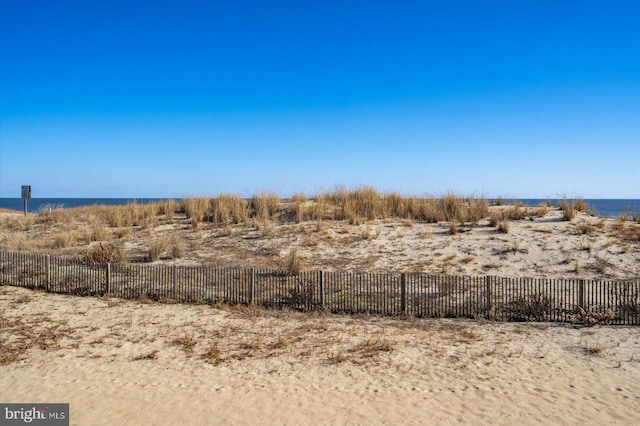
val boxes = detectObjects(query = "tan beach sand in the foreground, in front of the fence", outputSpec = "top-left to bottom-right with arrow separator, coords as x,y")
0,286 -> 640,425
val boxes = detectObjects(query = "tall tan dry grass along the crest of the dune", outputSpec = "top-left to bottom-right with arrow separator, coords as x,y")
0,186 -> 488,251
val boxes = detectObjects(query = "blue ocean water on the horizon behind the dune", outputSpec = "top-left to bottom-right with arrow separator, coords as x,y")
0,198 -> 640,217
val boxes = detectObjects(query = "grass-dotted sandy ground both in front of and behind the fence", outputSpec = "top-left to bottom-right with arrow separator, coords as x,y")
0,188 -> 640,425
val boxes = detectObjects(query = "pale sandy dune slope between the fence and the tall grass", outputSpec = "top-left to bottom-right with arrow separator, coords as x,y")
0,206 -> 640,280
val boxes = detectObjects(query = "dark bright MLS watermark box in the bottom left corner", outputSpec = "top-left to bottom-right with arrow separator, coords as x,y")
0,403 -> 69,426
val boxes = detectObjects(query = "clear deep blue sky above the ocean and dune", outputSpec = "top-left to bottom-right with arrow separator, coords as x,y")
0,0 -> 640,198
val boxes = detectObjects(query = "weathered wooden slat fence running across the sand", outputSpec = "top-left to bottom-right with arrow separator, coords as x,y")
0,250 -> 640,325
